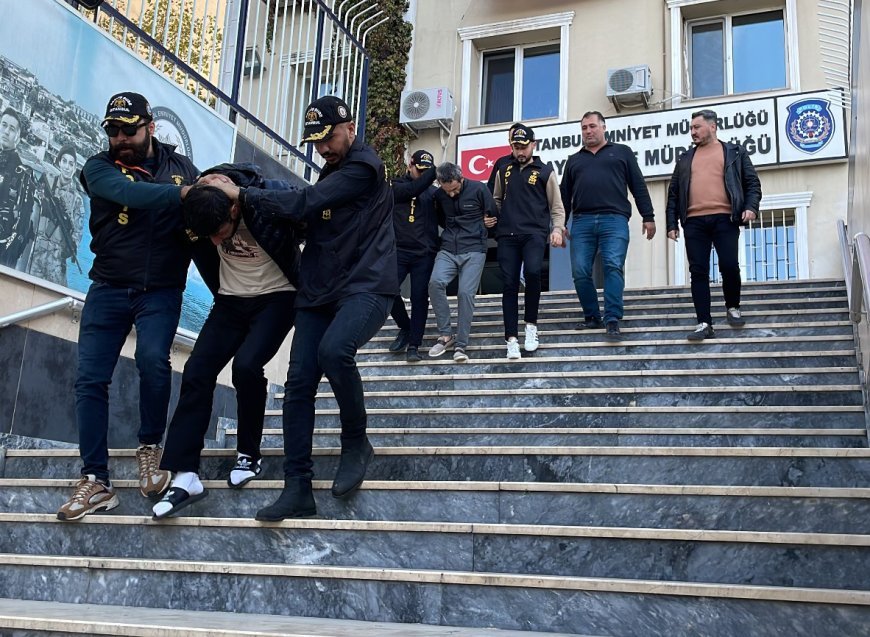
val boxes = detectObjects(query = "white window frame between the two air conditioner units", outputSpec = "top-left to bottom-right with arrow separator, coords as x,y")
458,11 -> 574,134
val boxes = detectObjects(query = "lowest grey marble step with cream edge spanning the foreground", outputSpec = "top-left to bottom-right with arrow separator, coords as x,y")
0,554 -> 870,637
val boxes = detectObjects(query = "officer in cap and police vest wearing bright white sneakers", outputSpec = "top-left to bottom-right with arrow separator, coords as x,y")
493,124 -> 565,360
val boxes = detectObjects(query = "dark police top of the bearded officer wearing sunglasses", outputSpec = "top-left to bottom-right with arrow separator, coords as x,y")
80,139 -> 198,290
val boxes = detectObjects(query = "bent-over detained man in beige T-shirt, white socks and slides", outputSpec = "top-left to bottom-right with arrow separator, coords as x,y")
153,164 -> 300,519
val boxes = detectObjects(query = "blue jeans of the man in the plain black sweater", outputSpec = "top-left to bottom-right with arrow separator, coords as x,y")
571,214 -> 629,323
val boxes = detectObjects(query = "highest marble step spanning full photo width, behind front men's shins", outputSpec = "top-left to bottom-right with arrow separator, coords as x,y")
2,446 -> 870,487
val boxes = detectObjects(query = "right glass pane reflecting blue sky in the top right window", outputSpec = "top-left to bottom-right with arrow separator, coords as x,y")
731,11 -> 786,93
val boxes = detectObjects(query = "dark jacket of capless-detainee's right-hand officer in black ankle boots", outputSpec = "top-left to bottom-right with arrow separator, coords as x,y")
239,137 -> 399,307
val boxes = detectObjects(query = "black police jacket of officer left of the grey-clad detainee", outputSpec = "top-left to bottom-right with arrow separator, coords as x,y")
393,166 -> 438,256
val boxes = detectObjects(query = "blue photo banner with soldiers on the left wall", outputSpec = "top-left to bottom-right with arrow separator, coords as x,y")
0,0 -> 235,331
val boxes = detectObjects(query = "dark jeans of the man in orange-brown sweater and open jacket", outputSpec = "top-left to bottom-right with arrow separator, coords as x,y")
683,214 -> 740,325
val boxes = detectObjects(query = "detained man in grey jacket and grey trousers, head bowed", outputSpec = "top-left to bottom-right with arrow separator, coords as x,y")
429,162 -> 498,363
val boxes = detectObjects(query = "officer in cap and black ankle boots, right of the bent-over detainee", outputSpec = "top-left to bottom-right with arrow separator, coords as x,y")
206,96 -> 399,521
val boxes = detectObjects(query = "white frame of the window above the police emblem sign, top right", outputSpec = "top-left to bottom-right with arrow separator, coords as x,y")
666,0 -> 801,108
